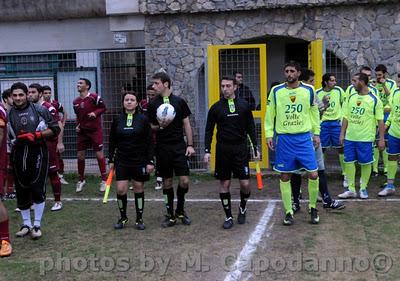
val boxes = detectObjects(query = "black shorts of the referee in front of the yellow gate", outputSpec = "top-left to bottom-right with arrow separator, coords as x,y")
214,143 -> 250,180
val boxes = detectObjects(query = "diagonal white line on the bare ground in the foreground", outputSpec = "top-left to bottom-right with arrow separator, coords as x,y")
224,202 -> 276,281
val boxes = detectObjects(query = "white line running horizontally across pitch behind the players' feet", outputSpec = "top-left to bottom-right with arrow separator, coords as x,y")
47,197 -> 400,203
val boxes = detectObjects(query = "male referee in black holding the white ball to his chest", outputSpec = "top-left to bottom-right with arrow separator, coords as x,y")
147,72 -> 195,227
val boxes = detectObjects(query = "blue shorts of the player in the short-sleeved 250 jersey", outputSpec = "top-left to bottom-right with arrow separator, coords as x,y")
344,140 -> 374,165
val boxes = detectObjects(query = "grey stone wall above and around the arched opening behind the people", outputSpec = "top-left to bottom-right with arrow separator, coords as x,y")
145,1 -> 400,102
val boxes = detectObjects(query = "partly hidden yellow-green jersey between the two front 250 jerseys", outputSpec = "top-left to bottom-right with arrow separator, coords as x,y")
317,86 -> 345,122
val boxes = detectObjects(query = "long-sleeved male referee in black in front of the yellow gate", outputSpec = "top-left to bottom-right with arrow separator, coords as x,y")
204,77 -> 259,229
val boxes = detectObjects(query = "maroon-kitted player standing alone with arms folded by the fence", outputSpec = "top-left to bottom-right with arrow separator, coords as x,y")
73,78 -> 107,192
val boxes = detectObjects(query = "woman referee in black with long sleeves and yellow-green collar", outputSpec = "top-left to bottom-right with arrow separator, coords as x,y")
109,91 -> 154,230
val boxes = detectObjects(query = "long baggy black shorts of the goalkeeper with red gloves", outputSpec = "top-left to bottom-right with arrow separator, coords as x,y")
11,144 -> 49,210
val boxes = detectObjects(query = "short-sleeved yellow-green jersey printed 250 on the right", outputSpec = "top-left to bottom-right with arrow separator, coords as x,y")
343,92 -> 383,142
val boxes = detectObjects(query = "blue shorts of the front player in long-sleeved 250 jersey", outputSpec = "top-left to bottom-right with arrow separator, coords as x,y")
274,133 -> 318,173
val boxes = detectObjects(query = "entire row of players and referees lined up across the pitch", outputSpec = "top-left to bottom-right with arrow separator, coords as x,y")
0,61 -> 400,257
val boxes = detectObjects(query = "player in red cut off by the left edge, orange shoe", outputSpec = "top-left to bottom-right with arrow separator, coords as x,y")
0,101 -> 12,257
